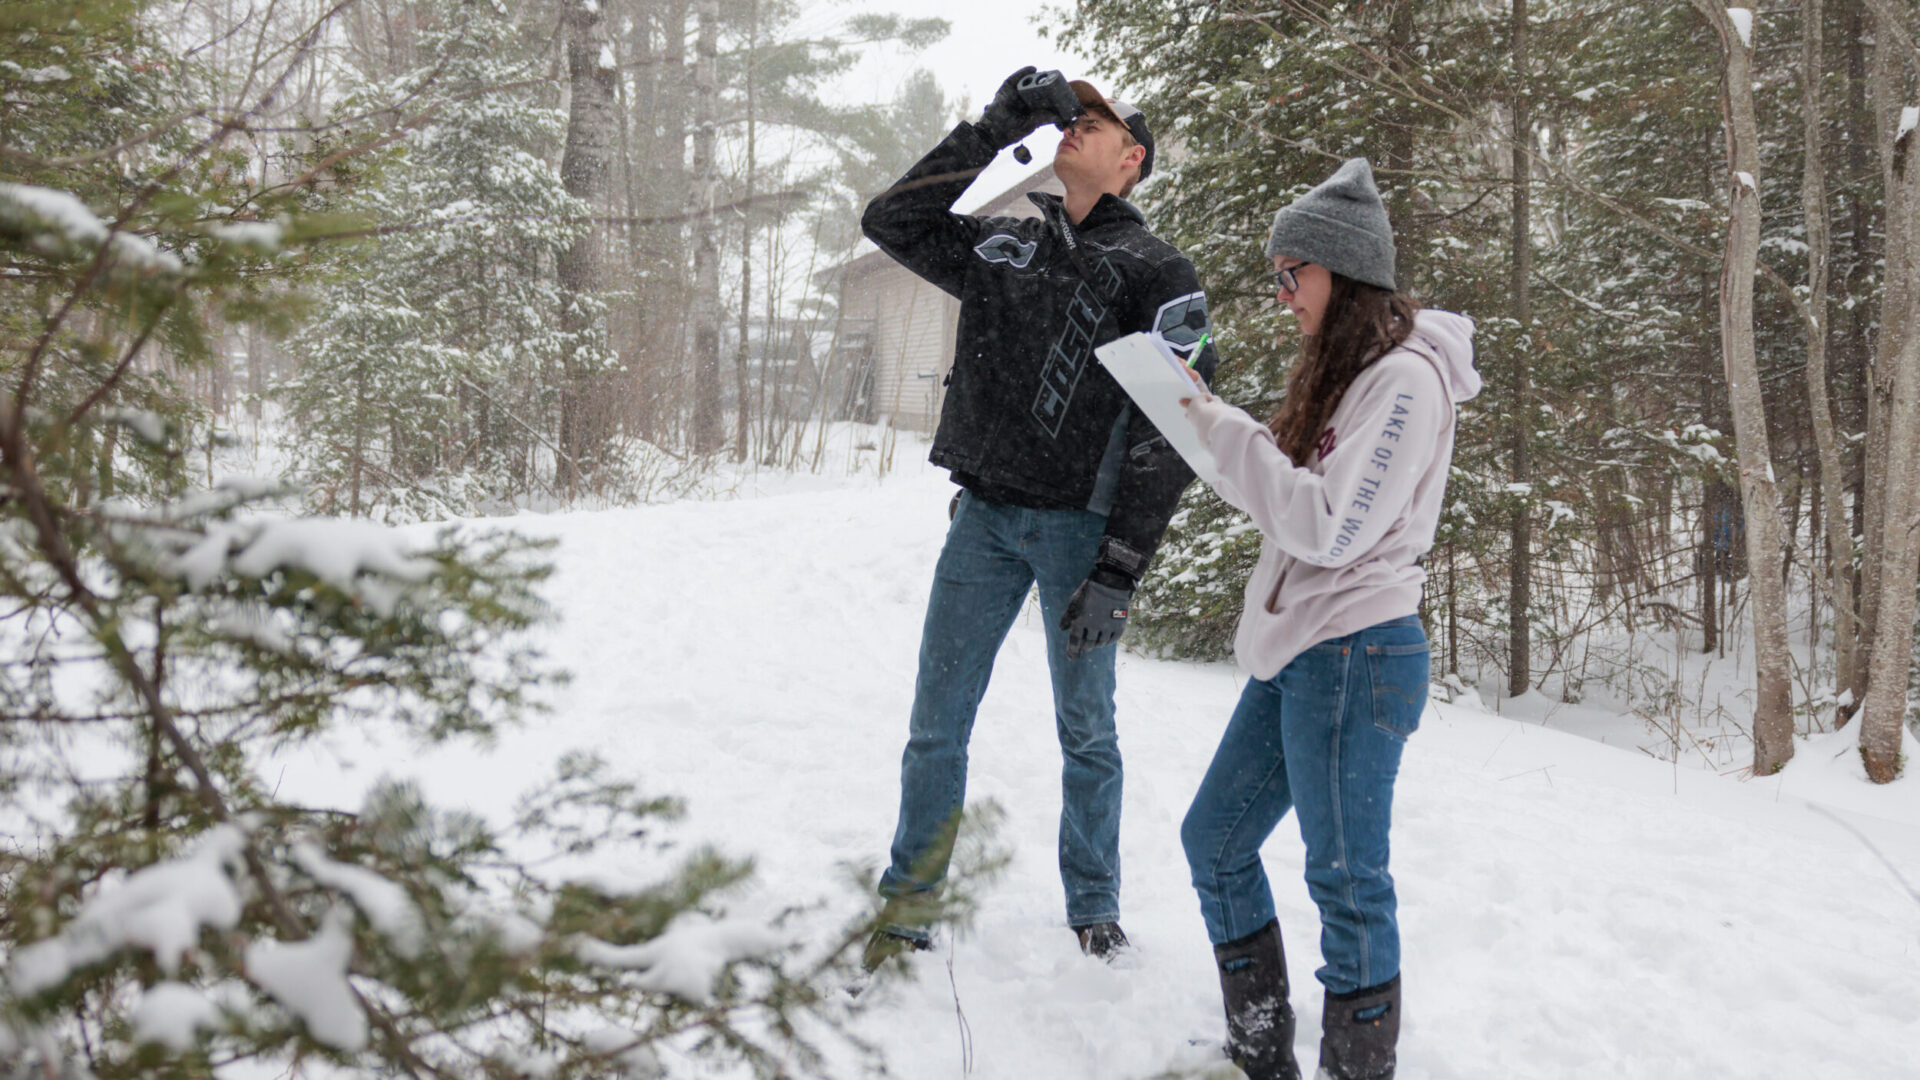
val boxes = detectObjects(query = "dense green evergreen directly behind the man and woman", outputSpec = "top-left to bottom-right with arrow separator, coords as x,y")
1064,2 -> 1501,657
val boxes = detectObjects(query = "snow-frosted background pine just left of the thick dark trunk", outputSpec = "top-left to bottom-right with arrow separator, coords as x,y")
282,2 -> 612,521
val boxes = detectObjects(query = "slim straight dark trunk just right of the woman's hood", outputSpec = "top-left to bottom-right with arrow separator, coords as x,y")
1507,0 -> 1534,698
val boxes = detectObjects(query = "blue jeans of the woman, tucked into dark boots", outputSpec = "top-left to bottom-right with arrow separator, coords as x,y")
1181,615 -> 1428,994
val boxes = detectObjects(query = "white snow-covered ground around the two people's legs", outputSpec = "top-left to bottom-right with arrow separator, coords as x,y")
259,442 -> 1920,1080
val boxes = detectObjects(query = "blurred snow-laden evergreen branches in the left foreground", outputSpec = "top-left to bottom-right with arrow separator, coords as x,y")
0,2 -> 990,1080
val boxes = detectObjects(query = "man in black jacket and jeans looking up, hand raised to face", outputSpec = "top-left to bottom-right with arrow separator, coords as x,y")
862,67 -> 1215,957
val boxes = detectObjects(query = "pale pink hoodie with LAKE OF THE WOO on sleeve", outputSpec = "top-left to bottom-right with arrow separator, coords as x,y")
1187,309 -> 1480,678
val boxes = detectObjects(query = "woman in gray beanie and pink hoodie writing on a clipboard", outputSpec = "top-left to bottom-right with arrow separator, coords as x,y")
1181,158 -> 1480,1080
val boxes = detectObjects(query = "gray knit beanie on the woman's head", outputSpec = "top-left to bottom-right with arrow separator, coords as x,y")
1267,158 -> 1394,288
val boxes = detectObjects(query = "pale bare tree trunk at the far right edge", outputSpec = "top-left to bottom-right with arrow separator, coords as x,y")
1860,0 -> 1920,784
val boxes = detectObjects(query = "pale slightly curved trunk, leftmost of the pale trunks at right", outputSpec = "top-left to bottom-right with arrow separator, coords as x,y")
1693,0 -> 1793,776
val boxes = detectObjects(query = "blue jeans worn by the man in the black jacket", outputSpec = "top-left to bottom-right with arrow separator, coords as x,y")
879,492 -> 1121,936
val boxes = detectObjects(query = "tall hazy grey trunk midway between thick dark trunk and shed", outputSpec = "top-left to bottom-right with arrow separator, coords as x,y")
687,0 -> 726,454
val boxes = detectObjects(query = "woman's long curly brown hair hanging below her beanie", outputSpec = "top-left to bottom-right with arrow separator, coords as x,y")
1267,273 -> 1415,465
